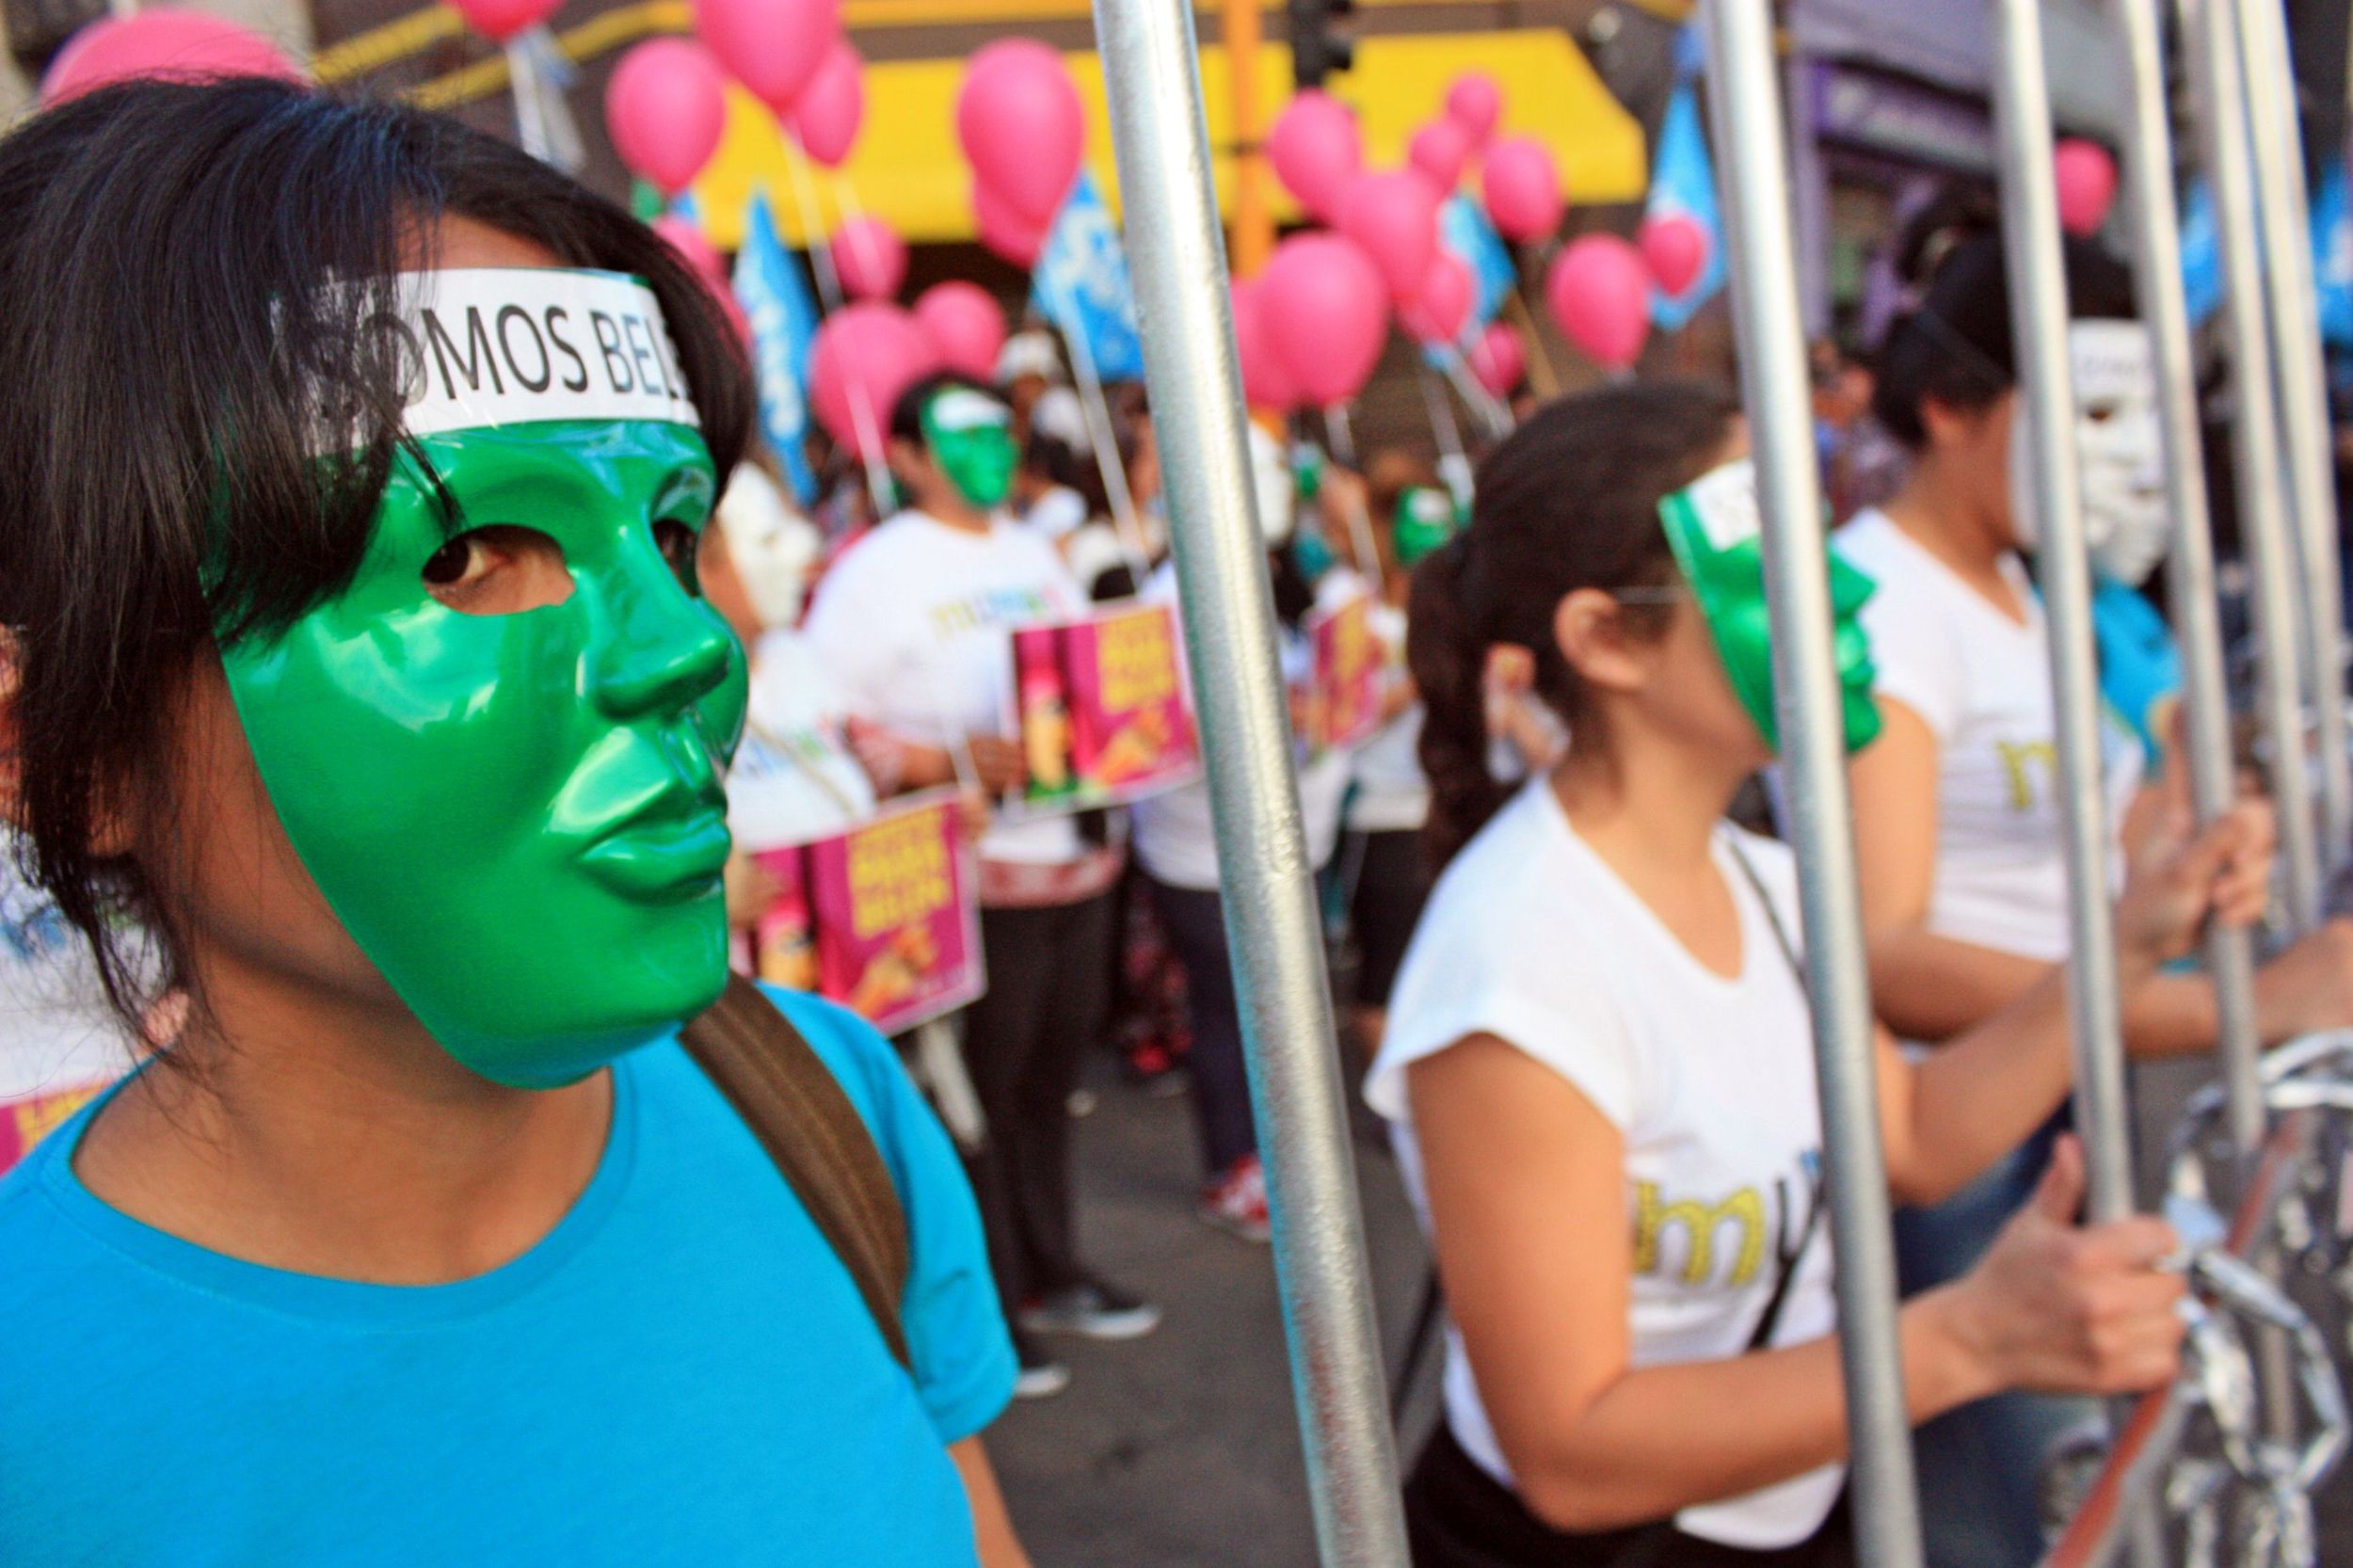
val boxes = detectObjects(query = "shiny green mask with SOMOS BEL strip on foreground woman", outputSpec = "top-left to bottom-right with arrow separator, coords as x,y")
224,271 -> 746,1088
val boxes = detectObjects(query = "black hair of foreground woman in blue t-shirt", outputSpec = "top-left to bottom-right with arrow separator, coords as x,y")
0,80 -> 753,1022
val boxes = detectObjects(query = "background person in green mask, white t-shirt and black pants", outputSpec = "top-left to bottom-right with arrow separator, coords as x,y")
808,375 -> 1160,1394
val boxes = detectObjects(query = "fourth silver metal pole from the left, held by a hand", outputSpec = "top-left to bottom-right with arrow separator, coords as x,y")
2111,0 -> 2264,1156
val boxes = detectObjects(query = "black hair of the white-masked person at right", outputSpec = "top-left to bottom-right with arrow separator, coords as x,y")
1871,193 -> 2137,450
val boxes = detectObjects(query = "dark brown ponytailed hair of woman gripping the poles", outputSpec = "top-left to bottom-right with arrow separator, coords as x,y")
1407,384 -> 1739,864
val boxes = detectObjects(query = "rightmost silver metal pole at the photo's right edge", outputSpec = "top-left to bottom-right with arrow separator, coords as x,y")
2238,0 -> 2353,883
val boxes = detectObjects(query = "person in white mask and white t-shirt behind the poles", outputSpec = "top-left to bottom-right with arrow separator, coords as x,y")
1838,212 -> 2353,1568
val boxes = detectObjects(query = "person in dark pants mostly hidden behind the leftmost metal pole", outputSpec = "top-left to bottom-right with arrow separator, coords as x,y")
1132,426 -> 1365,1240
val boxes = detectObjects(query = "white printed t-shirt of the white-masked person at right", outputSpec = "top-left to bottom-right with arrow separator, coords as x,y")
1838,511 -> 2141,963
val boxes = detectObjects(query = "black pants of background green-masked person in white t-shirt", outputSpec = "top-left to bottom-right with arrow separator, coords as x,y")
965,895 -> 1111,1311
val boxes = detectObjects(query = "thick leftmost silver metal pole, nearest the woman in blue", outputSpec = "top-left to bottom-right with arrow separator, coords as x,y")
1095,0 -> 1407,1568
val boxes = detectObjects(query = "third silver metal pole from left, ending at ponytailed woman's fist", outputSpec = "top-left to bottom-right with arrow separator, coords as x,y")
1993,0 -> 2132,1224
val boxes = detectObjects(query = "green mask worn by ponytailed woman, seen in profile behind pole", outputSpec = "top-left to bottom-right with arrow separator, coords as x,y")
1659,459 -> 1881,753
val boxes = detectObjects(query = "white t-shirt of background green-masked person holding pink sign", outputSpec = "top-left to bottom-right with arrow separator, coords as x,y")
805,511 -> 1087,867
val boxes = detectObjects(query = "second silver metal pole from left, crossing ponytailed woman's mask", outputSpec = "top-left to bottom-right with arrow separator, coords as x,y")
1702,11 -> 1923,1568
